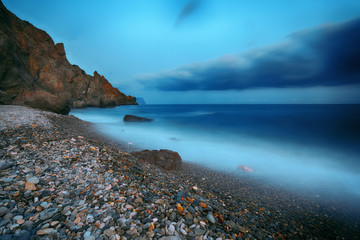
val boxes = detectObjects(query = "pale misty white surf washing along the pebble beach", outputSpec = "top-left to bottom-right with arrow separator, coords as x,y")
71,109 -> 360,197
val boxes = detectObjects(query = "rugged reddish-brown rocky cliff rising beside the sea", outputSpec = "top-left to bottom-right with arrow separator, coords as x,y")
0,1 -> 136,114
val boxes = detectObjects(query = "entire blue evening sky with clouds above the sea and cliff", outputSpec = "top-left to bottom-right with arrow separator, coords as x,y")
3,0 -> 360,104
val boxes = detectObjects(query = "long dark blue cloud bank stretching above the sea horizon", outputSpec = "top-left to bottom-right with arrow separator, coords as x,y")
138,18 -> 360,91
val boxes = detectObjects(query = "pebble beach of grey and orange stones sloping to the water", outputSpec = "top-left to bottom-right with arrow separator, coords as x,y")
0,106 -> 360,240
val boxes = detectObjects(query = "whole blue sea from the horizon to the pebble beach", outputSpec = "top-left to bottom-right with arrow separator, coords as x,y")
71,105 -> 360,199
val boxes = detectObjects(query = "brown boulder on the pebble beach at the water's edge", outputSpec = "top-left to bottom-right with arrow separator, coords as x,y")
131,149 -> 182,170
